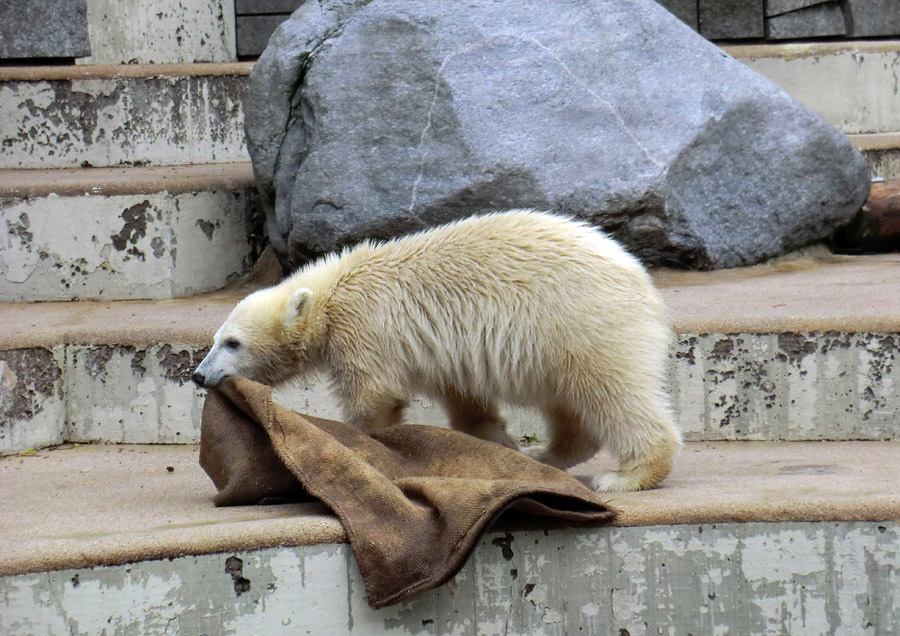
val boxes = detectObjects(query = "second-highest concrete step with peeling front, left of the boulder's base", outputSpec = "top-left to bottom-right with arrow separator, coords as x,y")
0,163 -> 264,301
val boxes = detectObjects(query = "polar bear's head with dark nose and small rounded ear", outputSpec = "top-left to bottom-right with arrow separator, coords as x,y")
191,286 -> 325,388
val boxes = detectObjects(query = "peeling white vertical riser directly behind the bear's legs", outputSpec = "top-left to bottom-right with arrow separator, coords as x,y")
0,332 -> 900,454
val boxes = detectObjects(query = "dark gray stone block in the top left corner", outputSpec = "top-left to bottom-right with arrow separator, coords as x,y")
0,0 -> 91,58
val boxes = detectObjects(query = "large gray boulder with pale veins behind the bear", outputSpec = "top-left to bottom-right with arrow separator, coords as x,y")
245,0 -> 869,268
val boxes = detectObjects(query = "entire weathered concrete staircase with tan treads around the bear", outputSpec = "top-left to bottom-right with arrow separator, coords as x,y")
0,27 -> 900,636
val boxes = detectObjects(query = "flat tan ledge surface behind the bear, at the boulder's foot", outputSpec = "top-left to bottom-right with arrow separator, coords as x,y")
0,248 -> 900,350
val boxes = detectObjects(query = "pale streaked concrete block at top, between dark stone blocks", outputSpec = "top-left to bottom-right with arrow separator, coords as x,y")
80,0 -> 237,64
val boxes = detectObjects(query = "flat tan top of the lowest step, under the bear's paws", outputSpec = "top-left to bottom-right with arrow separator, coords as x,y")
0,442 -> 900,576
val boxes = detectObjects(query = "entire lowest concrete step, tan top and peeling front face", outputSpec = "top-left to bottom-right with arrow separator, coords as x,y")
0,442 -> 900,636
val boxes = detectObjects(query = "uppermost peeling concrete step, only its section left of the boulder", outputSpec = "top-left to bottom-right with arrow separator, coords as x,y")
0,63 -> 252,169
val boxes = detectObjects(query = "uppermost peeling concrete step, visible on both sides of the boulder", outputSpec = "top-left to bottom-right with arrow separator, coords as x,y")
0,40 -> 900,174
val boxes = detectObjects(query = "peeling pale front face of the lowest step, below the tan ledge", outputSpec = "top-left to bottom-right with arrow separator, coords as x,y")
0,522 -> 900,636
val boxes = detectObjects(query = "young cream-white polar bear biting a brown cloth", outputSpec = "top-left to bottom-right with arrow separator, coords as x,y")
193,210 -> 681,491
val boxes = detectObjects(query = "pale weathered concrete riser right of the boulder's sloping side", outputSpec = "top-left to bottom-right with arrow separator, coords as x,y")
724,40 -> 900,134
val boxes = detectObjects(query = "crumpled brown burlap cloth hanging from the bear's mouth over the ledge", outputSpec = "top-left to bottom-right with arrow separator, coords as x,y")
200,378 -> 615,609
